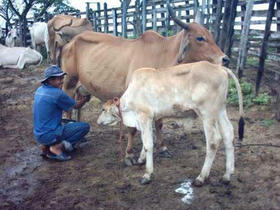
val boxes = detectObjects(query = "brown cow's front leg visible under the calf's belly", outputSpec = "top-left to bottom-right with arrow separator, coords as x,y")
155,119 -> 172,158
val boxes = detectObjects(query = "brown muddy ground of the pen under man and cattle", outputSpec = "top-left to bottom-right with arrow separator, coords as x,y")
0,66 -> 280,210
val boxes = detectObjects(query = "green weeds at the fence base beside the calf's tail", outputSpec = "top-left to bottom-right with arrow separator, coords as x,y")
227,79 -> 271,107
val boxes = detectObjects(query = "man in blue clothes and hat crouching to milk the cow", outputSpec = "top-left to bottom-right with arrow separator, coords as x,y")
33,65 -> 90,161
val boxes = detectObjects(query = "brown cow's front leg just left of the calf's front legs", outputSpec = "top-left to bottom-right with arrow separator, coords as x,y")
124,127 -> 137,166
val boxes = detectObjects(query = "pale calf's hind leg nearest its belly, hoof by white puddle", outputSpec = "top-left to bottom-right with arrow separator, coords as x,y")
194,118 -> 221,186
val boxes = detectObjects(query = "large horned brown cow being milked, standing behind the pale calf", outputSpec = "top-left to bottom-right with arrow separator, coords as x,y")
61,4 -> 229,164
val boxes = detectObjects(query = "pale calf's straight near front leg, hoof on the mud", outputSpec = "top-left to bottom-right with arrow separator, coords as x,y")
140,117 -> 154,185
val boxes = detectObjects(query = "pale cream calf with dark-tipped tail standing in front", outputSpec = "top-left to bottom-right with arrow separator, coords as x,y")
97,61 -> 244,186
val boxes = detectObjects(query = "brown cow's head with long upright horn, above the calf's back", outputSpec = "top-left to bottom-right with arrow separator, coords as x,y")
167,4 -> 229,65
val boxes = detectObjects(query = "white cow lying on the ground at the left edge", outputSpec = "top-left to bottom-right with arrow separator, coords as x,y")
0,44 -> 43,69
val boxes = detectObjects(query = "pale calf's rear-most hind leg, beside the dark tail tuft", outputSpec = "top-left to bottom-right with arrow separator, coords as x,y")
219,110 -> 234,183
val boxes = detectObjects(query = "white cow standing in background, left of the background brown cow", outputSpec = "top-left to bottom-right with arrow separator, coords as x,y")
30,22 -> 49,54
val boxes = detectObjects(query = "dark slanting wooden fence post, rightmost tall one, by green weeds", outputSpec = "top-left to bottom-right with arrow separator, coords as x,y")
256,0 -> 276,95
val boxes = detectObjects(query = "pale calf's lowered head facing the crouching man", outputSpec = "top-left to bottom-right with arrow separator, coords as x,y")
97,98 -> 120,126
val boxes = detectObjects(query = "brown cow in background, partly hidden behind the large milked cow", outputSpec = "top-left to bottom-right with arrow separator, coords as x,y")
48,15 -> 92,63
